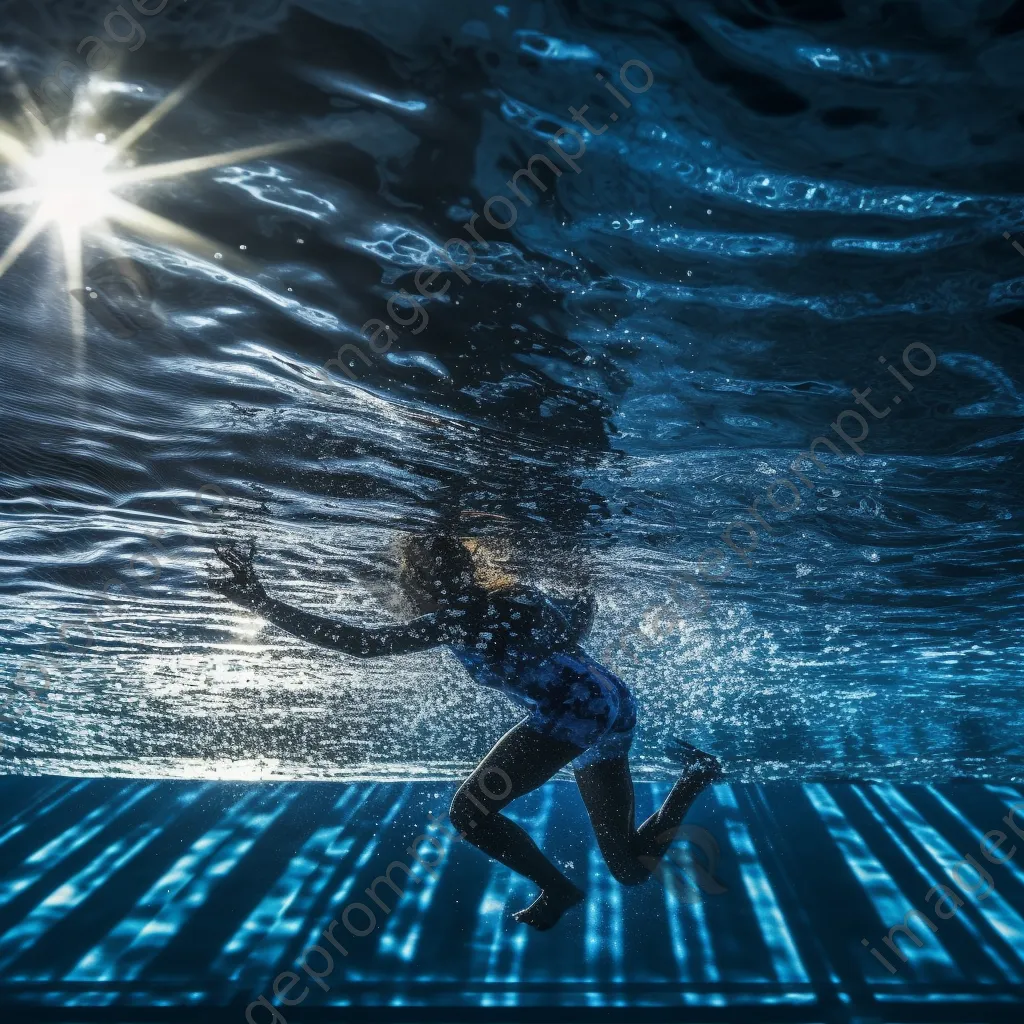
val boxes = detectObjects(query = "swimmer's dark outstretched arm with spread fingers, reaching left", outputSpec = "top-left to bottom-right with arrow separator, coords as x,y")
210,545 -> 445,657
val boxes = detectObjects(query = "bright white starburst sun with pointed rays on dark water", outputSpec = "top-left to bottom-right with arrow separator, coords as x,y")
0,58 -> 328,342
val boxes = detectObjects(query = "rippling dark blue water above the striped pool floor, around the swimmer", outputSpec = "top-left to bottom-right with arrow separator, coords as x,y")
0,0 -> 1024,780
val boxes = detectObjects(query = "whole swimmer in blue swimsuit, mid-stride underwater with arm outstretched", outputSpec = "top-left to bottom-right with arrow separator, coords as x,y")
210,535 -> 719,931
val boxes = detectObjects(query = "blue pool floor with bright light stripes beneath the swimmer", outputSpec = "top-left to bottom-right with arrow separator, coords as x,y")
0,776 -> 1024,1024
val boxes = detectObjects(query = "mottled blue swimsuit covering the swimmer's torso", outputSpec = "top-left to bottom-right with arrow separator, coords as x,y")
445,591 -> 636,767
